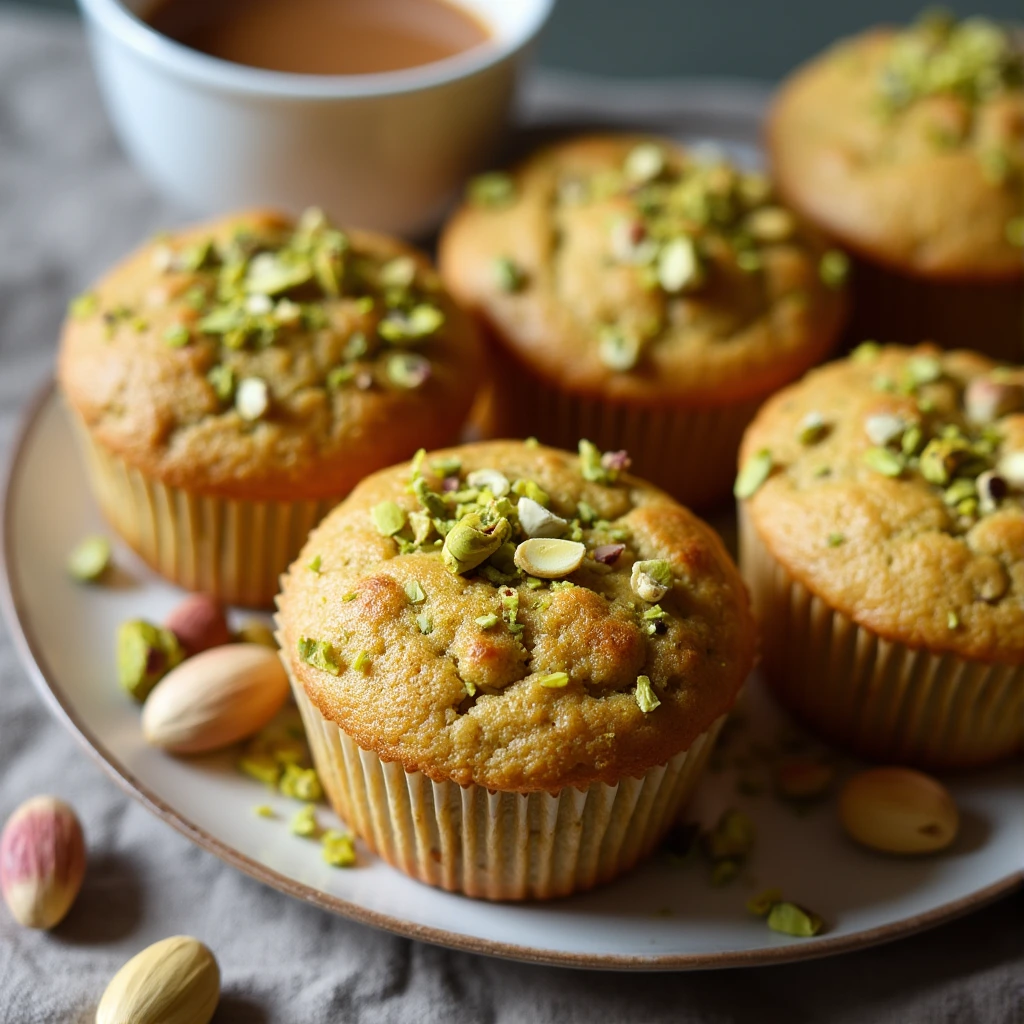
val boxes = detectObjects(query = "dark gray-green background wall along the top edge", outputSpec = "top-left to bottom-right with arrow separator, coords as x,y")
0,0 -> 1024,79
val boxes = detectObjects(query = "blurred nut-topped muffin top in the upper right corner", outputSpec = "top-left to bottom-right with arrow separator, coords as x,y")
768,16 -> 1024,280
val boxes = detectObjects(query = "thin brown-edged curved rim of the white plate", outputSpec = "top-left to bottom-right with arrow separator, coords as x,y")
0,378 -> 1024,971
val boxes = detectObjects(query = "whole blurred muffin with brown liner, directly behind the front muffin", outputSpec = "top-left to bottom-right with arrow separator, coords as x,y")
439,135 -> 846,506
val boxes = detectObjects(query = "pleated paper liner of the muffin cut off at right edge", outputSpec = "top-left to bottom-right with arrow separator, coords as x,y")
739,508 -> 1024,768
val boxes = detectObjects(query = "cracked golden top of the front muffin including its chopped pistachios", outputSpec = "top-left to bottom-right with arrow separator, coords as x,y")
278,441 -> 755,792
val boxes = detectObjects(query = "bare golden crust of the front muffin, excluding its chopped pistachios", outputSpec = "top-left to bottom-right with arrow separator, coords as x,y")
278,441 -> 755,792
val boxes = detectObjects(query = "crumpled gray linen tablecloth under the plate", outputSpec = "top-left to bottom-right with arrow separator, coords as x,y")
0,13 -> 1024,1024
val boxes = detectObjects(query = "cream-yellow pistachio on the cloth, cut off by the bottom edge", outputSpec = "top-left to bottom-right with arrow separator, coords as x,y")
96,935 -> 220,1024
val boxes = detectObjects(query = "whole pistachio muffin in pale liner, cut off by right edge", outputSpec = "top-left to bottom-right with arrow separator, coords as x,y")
736,344 -> 1024,768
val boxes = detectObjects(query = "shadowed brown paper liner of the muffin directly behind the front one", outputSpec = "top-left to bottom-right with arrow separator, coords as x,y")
493,346 -> 769,508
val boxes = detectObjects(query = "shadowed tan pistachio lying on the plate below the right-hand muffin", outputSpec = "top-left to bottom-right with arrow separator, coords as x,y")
839,768 -> 959,854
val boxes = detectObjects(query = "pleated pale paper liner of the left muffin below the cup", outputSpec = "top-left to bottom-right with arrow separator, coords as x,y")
76,423 -> 336,608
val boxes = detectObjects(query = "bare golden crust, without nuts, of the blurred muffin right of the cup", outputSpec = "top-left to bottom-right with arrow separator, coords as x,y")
438,135 -> 845,406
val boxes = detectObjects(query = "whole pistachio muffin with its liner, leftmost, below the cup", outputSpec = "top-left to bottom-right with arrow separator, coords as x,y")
57,211 -> 481,605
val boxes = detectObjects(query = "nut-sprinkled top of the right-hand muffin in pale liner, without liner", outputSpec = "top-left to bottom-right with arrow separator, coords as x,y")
737,344 -> 1024,665
